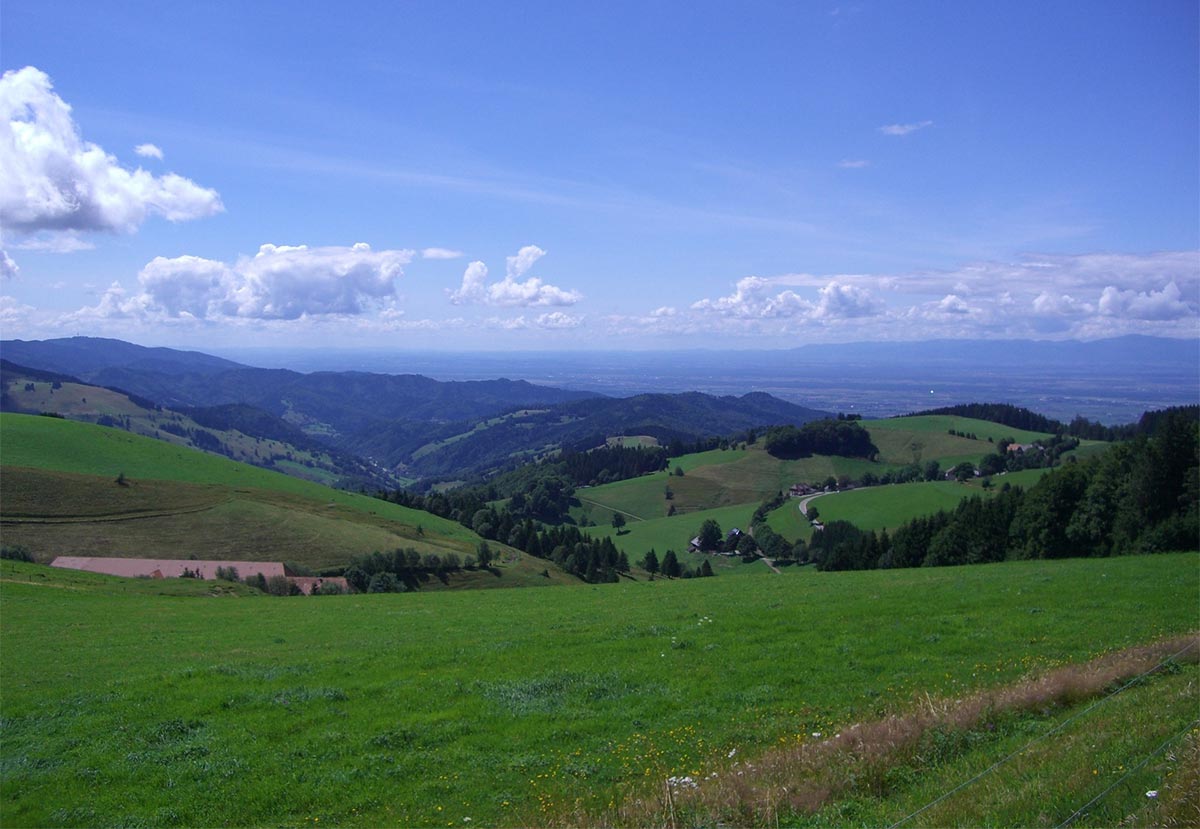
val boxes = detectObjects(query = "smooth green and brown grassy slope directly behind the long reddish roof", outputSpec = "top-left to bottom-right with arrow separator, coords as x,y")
0,414 -> 557,581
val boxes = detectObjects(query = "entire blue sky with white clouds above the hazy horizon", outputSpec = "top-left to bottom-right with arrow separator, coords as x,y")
0,0 -> 1200,350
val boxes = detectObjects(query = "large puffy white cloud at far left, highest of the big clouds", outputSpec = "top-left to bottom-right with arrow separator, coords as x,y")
0,66 -> 223,234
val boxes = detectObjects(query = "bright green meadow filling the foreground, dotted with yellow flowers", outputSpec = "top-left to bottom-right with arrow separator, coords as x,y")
0,554 -> 1200,827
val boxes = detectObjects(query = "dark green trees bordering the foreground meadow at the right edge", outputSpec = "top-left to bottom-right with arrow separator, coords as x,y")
800,407 -> 1200,570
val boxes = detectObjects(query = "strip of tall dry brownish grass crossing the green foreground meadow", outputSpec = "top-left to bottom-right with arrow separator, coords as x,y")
576,633 -> 1200,829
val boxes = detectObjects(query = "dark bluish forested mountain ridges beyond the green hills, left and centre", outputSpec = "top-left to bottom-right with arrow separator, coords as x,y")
0,337 -> 828,477
